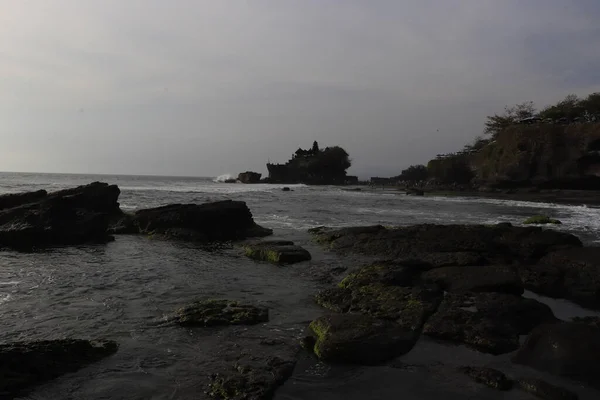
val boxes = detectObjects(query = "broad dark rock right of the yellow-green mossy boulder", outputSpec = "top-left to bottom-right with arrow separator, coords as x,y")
423,293 -> 556,354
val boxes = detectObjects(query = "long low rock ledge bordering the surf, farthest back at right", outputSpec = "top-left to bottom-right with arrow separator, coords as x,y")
310,223 -> 582,265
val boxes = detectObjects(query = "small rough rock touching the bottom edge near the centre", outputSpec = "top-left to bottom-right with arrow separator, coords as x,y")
208,357 -> 295,400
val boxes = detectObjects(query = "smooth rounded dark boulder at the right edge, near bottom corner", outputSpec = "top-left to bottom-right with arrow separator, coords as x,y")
513,322 -> 600,388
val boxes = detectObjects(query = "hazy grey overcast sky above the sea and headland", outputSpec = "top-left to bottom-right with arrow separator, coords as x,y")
0,0 -> 600,178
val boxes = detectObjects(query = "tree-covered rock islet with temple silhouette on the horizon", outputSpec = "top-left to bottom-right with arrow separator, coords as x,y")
267,142 -> 356,185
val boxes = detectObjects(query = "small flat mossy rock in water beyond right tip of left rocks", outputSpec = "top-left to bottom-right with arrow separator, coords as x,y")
244,241 -> 312,265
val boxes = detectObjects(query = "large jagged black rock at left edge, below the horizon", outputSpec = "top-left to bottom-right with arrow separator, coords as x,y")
0,182 -> 121,250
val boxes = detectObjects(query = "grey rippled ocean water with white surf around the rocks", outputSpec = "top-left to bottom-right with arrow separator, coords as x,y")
0,173 -> 600,400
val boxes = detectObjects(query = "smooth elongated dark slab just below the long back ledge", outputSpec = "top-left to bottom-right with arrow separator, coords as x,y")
422,265 -> 523,295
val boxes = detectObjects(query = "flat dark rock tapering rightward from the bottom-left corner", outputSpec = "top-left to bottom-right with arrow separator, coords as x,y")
0,339 -> 118,399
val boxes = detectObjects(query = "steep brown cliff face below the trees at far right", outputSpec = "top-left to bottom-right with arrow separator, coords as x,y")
469,123 -> 600,189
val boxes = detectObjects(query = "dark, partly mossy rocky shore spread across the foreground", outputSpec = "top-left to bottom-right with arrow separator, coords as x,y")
0,182 -> 600,400
